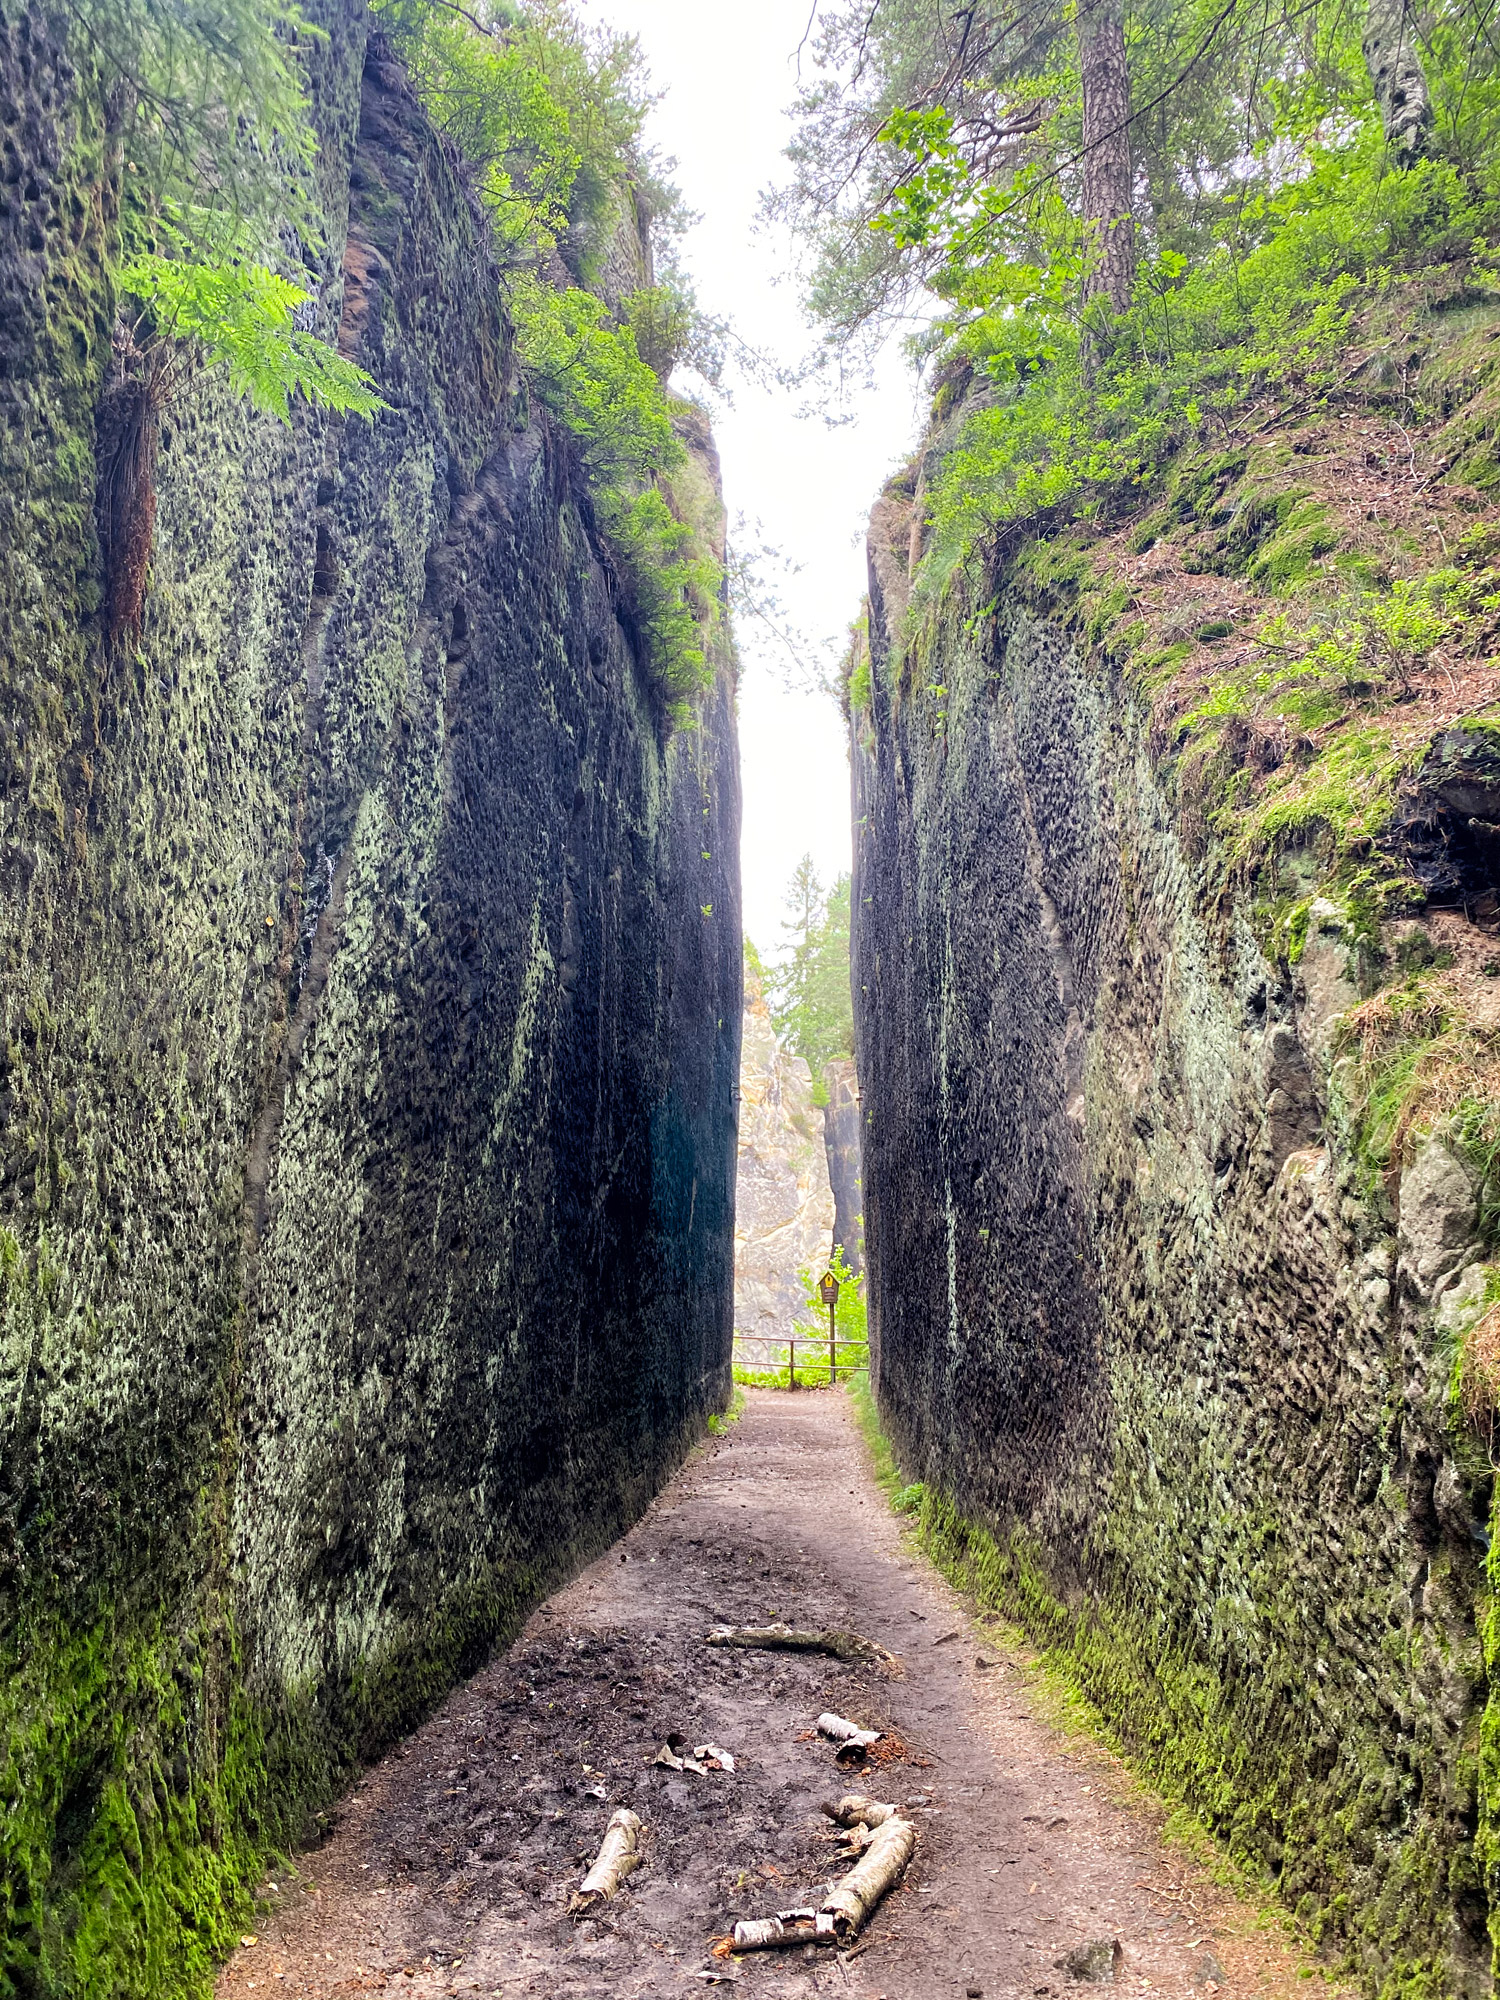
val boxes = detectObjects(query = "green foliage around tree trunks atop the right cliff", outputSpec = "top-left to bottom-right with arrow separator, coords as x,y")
782,0 -> 1500,588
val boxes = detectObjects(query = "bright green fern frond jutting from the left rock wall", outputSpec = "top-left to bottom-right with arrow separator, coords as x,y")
118,254 -> 386,424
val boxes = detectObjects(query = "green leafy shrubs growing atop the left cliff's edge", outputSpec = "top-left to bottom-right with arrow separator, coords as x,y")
376,0 -> 722,724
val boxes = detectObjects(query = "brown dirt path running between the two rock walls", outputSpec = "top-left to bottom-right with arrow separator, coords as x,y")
218,1390 -> 1336,2000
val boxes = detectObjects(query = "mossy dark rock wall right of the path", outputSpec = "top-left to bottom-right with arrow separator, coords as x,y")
850,406 -> 1500,1994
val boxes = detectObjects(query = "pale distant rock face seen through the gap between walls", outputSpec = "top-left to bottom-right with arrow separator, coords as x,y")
734,970 -> 834,1368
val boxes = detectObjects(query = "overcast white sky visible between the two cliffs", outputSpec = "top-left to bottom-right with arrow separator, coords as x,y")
588,0 -> 914,952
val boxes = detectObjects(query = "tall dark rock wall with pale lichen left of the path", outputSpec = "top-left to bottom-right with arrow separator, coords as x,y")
0,6 -> 740,2000
